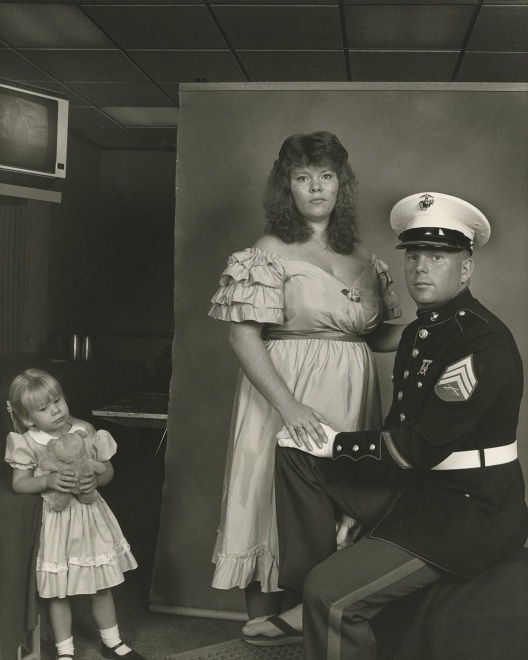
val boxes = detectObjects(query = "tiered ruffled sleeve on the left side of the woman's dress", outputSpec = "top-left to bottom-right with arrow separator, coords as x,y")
209,248 -> 286,324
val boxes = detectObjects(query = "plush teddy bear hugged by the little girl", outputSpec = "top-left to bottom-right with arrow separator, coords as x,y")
39,429 -> 106,511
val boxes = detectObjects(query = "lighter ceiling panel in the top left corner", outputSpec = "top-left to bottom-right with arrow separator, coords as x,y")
0,2 -> 111,48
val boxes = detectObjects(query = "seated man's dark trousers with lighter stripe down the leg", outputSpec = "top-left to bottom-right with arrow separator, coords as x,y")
275,447 -> 446,660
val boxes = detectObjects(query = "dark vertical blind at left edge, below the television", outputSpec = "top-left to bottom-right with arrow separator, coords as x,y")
0,198 -> 29,354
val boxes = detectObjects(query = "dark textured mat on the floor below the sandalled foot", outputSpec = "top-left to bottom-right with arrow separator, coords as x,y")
167,639 -> 303,660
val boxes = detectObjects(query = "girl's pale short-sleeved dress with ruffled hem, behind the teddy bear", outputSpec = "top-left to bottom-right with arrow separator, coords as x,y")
5,419 -> 137,598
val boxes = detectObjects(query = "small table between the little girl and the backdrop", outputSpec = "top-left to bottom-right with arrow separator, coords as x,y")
92,392 -> 169,464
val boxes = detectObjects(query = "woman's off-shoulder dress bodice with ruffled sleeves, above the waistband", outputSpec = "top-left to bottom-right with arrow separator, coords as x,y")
209,248 -> 401,339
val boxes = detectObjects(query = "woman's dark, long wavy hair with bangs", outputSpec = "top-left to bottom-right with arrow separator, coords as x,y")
264,131 -> 359,254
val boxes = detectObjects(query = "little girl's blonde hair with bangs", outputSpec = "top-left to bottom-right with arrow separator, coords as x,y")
7,369 -> 64,433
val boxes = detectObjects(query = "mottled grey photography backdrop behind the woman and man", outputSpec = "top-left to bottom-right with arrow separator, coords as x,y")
151,83 -> 528,616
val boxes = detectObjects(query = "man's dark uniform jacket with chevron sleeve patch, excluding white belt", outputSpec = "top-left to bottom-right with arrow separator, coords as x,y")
333,290 -> 528,577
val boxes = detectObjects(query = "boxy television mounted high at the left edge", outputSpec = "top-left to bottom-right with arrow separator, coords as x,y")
0,78 -> 68,183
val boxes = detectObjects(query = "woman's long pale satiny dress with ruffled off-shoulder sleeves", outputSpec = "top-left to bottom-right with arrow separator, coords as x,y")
209,248 -> 401,592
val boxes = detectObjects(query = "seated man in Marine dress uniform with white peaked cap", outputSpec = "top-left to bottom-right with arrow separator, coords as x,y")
276,193 -> 528,660
